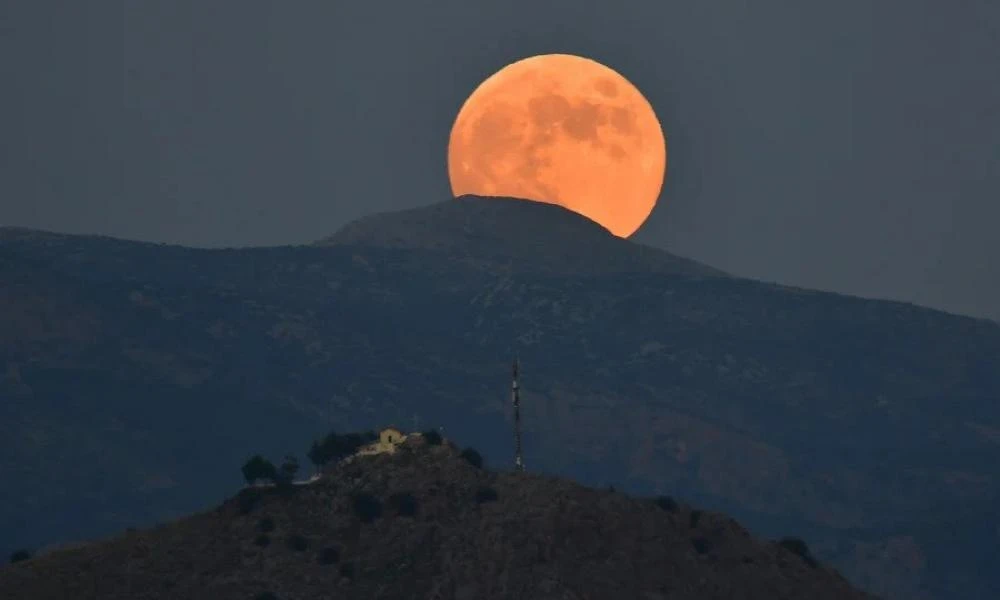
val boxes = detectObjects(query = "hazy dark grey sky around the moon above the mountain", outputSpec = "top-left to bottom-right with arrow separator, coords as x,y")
0,0 -> 1000,319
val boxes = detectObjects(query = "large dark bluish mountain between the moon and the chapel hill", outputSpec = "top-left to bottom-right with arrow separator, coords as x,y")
0,198 -> 1000,600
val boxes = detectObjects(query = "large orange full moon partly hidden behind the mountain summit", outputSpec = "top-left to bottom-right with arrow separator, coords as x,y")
448,54 -> 667,237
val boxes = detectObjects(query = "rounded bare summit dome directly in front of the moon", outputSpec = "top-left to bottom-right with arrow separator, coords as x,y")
316,195 -> 725,276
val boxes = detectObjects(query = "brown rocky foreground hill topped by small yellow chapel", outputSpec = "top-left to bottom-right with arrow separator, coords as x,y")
0,438 -> 868,600
